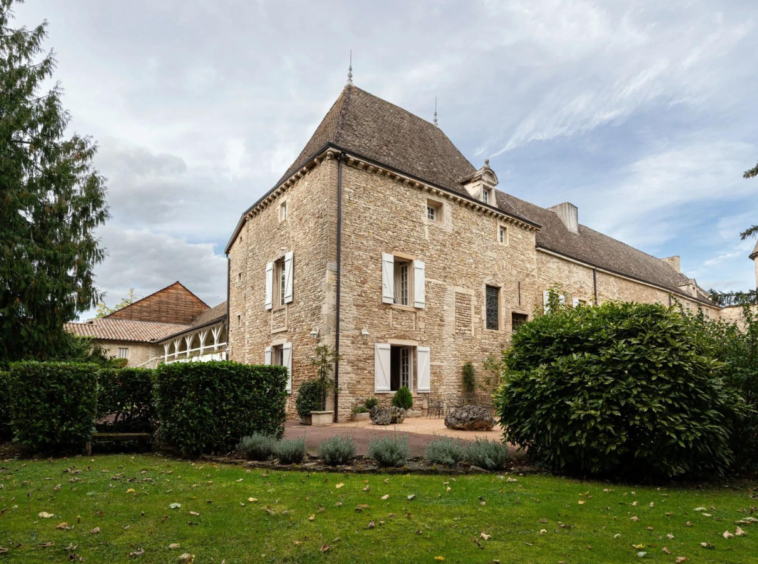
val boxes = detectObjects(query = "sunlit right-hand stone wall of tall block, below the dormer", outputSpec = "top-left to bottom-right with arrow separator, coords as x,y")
339,161 -> 539,419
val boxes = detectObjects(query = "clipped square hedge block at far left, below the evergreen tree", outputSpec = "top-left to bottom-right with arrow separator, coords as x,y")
8,362 -> 97,451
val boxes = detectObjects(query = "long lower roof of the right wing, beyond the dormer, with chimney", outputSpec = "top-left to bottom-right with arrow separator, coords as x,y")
497,192 -> 710,303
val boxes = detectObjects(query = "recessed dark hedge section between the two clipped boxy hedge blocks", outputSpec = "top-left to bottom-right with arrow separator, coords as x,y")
96,368 -> 158,433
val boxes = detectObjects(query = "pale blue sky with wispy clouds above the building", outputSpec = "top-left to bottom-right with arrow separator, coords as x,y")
10,0 -> 758,319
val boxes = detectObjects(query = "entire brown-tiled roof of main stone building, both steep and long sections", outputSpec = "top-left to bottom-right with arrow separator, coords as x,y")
232,85 -> 712,301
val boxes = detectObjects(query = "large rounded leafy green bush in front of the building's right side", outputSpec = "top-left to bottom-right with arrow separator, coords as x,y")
496,302 -> 745,477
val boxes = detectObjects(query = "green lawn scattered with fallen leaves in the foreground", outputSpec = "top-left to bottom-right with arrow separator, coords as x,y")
0,455 -> 758,564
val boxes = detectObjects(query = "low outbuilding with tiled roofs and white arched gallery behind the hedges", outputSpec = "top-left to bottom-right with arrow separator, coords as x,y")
66,282 -> 227,368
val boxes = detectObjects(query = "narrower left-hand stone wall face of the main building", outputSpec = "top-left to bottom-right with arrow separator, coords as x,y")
229,158 -> 337,414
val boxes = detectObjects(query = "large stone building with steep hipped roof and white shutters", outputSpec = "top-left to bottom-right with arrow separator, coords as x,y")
226,84 -> 736,420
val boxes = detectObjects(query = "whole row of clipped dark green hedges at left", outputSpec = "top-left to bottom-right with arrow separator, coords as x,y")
0,362 -> 287,455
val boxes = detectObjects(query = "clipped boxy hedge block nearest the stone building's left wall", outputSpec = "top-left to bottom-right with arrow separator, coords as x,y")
156,361 -> 287,455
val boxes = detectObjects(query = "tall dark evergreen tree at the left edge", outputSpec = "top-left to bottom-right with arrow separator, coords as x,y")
0,0 -> 108,363
